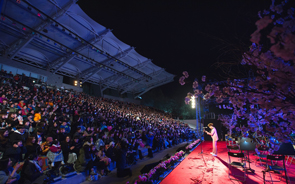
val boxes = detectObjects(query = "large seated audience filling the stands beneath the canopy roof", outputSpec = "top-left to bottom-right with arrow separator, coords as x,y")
0,70 -> 197,184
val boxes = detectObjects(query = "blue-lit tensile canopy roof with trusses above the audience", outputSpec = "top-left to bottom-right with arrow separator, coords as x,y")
0,0 -> 174,95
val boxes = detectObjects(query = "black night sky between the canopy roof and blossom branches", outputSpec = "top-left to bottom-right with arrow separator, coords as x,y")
78,0 -> 271,118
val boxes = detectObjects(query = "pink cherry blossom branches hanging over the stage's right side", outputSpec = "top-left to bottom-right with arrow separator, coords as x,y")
179,0 -> 295,150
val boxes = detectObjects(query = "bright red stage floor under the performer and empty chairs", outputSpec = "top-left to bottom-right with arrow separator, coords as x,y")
160,141 -> 295,184
